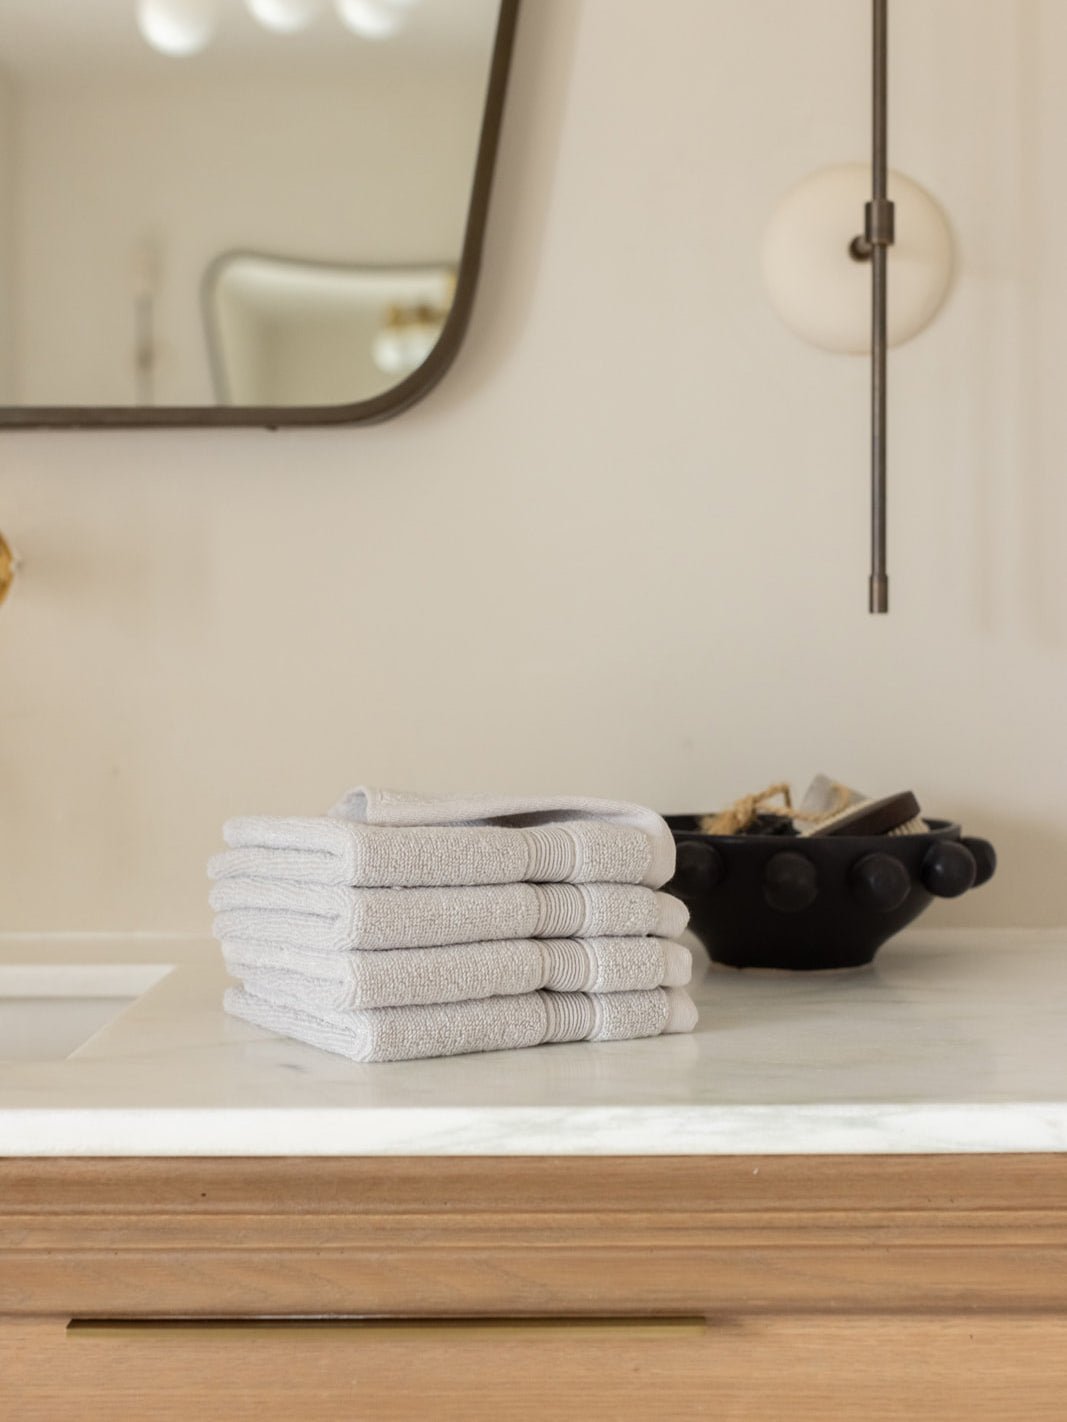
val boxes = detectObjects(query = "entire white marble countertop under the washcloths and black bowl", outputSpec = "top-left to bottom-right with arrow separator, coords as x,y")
0,930 -> 1067,1156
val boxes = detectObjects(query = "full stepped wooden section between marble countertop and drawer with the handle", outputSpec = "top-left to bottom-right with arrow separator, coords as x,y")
0,1156 -> 1067,1315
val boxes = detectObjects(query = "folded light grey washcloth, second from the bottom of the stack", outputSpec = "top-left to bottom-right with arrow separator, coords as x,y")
222,937 -> 693,1011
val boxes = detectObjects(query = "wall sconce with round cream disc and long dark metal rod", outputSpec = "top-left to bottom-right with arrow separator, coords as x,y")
763,0 -> 952,613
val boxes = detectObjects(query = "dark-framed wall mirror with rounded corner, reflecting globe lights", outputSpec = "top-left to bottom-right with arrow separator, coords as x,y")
0,0 -> 518,428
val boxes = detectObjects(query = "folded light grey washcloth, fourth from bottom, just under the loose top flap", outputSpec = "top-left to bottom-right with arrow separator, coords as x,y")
208,815 -> 673,889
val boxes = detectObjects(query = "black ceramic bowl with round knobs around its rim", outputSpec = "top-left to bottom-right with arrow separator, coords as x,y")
666,815 -> 996,970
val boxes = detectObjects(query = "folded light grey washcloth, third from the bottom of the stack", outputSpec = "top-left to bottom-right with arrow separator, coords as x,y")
209,877 -> 689,953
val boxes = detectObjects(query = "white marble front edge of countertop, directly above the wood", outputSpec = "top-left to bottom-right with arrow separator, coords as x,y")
0,1102 -> 1067,1159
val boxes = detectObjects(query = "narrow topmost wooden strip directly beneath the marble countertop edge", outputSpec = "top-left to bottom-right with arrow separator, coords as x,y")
0,1155 -> 1067,1214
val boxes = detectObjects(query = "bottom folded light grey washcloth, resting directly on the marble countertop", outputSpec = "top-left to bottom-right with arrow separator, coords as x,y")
223,987 -> 697,1062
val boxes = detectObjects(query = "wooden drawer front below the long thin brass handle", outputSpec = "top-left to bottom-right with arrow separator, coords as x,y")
8,1314 -> 1067,1422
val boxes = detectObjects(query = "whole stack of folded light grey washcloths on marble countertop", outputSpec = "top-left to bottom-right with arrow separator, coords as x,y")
209,789 -> 696,1062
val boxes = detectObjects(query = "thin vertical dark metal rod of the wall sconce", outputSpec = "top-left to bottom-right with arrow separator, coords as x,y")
864,0 -> 893,613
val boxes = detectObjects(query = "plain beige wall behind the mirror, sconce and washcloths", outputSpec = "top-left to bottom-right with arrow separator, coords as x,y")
0,0 -> 1067,929
